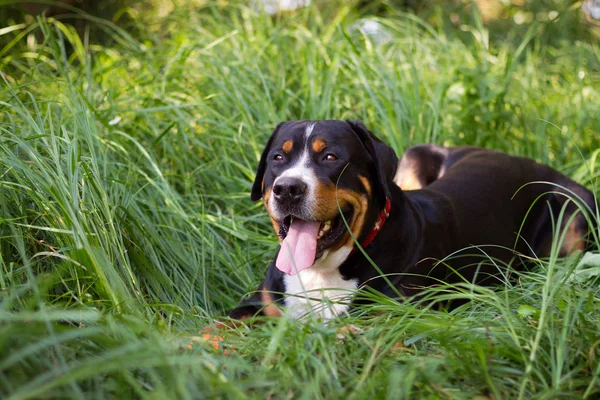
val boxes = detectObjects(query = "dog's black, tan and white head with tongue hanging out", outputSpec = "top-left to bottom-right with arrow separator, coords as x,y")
251,121 -> 398,275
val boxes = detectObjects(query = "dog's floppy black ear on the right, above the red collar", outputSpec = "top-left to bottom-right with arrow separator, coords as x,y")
346,121 -> 398,199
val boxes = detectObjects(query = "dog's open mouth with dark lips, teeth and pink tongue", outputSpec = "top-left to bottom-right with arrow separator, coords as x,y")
275,206 -> 353,275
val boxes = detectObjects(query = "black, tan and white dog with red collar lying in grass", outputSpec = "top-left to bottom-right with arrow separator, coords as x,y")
229,120 -> 597,320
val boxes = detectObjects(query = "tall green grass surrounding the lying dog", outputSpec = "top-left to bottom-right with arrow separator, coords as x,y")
0,2 -> 600,399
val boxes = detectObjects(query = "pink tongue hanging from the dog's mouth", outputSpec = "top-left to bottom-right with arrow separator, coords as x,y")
275,218 -> 321,275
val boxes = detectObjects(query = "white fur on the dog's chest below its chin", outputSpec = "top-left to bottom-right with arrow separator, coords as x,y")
284,248 -> 358,320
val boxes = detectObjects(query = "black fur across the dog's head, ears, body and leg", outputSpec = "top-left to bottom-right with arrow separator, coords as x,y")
230,121 -> 596,318
